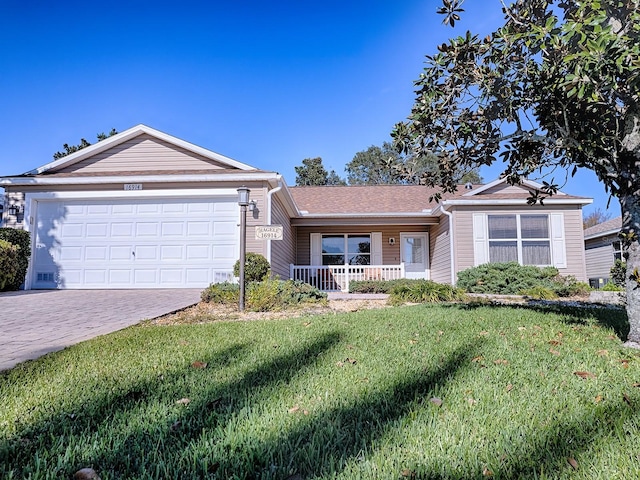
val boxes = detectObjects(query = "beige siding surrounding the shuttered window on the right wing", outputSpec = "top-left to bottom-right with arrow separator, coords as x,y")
454,205 -> 587,281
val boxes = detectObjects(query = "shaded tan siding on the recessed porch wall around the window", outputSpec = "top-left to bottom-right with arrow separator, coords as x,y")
296,225 -> 429,265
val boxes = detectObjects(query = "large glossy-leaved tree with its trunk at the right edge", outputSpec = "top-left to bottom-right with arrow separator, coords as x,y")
392,0 -> 640,342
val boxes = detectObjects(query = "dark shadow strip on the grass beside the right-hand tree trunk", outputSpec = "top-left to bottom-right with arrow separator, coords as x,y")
456,300 -> 629,341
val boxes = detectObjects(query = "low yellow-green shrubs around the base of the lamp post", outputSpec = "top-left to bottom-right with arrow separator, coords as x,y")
201,279 -> 327,312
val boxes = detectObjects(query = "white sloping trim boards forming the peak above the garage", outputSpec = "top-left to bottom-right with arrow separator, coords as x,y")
24,124 -> 256,175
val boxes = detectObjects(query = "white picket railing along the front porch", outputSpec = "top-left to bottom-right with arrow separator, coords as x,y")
289,263 -> 404,292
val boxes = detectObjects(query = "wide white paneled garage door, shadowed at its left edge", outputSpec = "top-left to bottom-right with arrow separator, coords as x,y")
32,198 -> 239,288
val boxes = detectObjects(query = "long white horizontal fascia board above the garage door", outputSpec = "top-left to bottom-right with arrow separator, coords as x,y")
0,171 -> 278,186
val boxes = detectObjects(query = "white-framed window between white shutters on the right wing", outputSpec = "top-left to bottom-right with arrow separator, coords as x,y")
487,214 -> 551,266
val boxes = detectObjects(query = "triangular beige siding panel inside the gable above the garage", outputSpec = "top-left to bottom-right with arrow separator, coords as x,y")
57,133 -> 229,174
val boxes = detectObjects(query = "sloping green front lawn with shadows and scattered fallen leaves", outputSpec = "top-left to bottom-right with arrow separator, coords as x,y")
0,305 -> 640,480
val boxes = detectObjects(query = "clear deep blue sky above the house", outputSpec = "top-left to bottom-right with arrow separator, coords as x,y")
0,0 -> 619,216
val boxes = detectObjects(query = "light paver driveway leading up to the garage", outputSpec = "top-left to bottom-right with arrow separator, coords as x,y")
0,289 -> 202,371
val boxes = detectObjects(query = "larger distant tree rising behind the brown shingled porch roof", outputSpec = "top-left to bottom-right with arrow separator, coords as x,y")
345,142 -> 482,185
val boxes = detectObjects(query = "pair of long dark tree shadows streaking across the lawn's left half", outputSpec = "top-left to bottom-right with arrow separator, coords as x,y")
0,332 -> 341,479
